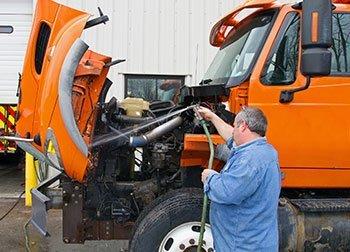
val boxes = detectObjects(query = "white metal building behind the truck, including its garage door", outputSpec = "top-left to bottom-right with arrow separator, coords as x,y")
0,0 -> 241,103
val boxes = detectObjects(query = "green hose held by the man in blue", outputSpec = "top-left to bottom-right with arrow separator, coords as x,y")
193,107 -> 214,252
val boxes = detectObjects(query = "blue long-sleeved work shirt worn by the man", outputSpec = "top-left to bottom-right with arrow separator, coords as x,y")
204,138 -> 281,252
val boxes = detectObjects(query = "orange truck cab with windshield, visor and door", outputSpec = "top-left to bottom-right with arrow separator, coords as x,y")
197,1 -> 350,188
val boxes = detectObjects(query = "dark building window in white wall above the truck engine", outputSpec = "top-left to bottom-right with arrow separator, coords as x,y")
125,75 -> 185,103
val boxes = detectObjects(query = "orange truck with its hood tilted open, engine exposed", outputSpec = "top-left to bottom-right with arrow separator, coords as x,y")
17,0 -> 350,251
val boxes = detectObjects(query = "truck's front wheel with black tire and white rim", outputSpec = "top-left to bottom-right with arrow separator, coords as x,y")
129,188 -> 214,252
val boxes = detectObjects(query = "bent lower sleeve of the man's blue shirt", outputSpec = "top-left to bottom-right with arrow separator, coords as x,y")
204,160 -> 259,205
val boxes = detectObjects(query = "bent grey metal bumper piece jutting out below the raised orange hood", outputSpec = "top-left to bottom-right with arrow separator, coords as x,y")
30,172 -> 62,236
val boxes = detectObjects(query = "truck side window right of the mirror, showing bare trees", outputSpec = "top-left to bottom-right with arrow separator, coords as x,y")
331,13 -> 350,74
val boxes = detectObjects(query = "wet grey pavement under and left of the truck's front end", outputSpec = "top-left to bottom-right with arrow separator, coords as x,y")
0,159 -> 128,252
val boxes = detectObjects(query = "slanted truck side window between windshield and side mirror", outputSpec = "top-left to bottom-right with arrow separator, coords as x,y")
261,13 -> 300,85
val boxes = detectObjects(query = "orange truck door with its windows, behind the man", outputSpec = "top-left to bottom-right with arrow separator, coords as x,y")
249,9 -> 350,187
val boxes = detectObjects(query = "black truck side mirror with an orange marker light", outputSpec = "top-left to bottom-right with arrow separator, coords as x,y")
301,0 -> 332,77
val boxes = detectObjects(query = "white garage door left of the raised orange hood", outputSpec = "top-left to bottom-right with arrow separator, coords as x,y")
0,0 -> 33,104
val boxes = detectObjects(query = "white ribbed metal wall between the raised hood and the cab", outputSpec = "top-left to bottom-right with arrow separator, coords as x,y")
59,0 -> 241,99
